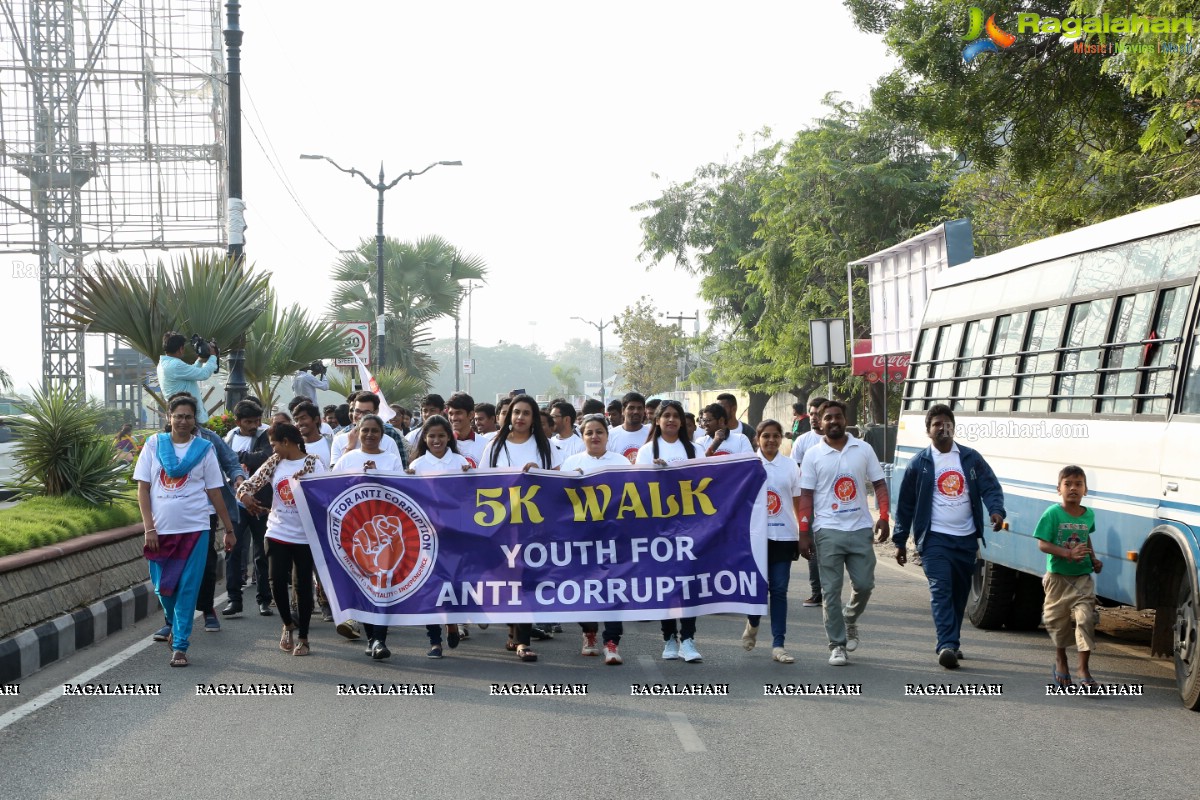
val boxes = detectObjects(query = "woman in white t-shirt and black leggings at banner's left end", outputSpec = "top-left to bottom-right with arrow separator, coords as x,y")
238,422 -> 325,656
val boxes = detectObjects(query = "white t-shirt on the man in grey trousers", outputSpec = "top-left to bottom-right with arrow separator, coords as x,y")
800,433 -> 883,530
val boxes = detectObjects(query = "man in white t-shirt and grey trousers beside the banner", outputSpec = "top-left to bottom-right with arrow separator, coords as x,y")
799,401 -> 889,667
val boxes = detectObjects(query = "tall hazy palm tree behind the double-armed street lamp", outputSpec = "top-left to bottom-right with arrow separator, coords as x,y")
329,236 -> 487,386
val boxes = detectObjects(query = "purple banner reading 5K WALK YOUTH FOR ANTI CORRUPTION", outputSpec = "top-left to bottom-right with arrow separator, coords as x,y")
292,456 -> 767,625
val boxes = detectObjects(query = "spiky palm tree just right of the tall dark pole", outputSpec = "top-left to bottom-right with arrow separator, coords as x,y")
245,289 -> 344,409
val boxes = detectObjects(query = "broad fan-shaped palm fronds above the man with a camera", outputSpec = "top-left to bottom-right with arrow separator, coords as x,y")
70,252 -> 266,363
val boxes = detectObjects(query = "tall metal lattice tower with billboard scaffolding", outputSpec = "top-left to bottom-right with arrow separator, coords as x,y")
0,0 -> 227,396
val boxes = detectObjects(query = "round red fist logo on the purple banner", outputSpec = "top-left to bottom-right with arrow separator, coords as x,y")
328,483 -> 438,604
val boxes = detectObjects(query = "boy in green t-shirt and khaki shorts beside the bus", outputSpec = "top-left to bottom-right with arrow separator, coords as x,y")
1033,467 -> 1103,688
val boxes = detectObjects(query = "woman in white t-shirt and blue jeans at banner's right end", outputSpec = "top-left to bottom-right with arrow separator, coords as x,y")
742,420 -> 800,664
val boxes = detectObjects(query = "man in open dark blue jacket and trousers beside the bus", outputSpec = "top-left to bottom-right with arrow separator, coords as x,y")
892,404 -> 1004,669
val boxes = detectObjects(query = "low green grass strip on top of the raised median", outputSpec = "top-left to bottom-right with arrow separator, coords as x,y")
0,495 -> 142,555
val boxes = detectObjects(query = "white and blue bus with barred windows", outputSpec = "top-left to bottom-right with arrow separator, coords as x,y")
893,197 -> 1200,709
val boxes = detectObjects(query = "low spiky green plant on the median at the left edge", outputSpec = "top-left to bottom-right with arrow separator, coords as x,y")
8,386 -> 126,504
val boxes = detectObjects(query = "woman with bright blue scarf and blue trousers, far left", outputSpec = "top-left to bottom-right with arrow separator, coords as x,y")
133,395 -> 234,667
